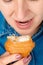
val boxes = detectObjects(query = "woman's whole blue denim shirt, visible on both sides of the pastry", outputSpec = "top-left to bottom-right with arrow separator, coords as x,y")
0,13 -> 43,65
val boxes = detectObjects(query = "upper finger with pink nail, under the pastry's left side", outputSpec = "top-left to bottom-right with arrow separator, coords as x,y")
1,54 -> 21,64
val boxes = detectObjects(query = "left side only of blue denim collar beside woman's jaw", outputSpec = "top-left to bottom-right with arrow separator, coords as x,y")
0,14 -> 19,37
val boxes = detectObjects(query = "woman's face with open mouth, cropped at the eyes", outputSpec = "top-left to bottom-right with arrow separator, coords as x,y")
0,0 -> 43,36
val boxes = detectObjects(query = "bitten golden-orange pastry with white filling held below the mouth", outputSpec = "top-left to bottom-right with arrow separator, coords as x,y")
5,35 -> 35,57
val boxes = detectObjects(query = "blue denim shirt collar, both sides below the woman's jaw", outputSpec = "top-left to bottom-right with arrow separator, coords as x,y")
0,13 -> 43,39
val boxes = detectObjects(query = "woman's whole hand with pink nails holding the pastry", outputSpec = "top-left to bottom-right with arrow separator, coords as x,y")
0,52 -> 31,65
